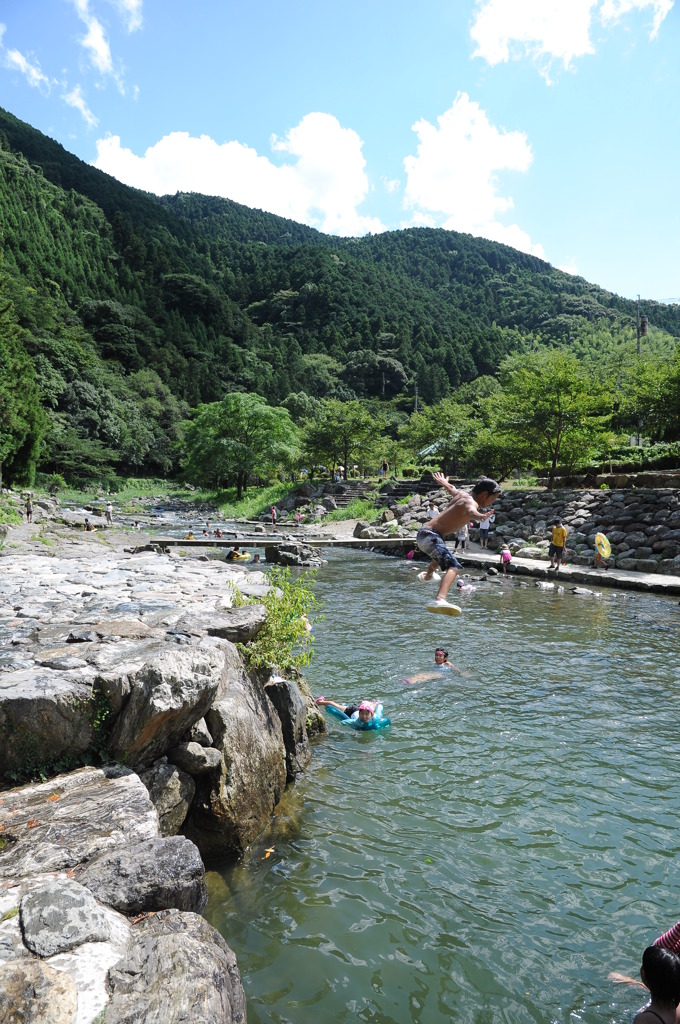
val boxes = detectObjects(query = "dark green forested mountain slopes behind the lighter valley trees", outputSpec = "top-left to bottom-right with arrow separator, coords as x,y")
0,102 -> 680,478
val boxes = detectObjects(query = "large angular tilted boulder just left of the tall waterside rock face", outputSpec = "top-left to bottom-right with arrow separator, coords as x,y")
111,647 -> 224,765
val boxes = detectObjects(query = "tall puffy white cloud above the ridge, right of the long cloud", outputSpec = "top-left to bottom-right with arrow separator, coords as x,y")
403,92 -> 543,256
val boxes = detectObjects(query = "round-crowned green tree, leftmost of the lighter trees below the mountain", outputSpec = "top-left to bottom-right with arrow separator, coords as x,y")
182,393 -> 299,501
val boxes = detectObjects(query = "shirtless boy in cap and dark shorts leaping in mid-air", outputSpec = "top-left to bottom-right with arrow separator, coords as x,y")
416,473 -> 501,615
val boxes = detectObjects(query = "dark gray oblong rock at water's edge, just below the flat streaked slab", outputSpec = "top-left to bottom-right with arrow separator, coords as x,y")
79,836 -> 208,913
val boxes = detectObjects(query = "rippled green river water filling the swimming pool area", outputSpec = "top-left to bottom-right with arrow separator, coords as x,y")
206,552 -> 680,1024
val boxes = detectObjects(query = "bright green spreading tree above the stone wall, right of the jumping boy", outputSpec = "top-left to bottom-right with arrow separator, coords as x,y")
492,349 -> 612,487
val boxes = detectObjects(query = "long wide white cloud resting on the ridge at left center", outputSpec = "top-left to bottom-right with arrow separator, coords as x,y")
94,113 -> 385,234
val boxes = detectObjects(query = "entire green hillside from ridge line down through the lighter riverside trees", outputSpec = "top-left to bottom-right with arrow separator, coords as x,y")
0,103 -> 680,494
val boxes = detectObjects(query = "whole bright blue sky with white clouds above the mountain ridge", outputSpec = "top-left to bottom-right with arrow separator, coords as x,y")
0,0 -> 680,302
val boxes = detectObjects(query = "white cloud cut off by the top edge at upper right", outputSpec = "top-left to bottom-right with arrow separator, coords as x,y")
470,0 -> 674,79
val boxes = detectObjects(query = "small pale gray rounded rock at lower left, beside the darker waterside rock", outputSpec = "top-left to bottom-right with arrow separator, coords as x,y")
19,879 -> 110,957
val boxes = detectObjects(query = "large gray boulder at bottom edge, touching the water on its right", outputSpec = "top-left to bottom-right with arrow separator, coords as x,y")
105,910 -> 246,1024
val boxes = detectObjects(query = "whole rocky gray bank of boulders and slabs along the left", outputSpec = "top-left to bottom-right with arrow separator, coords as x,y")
0,493 -> 323,1024
